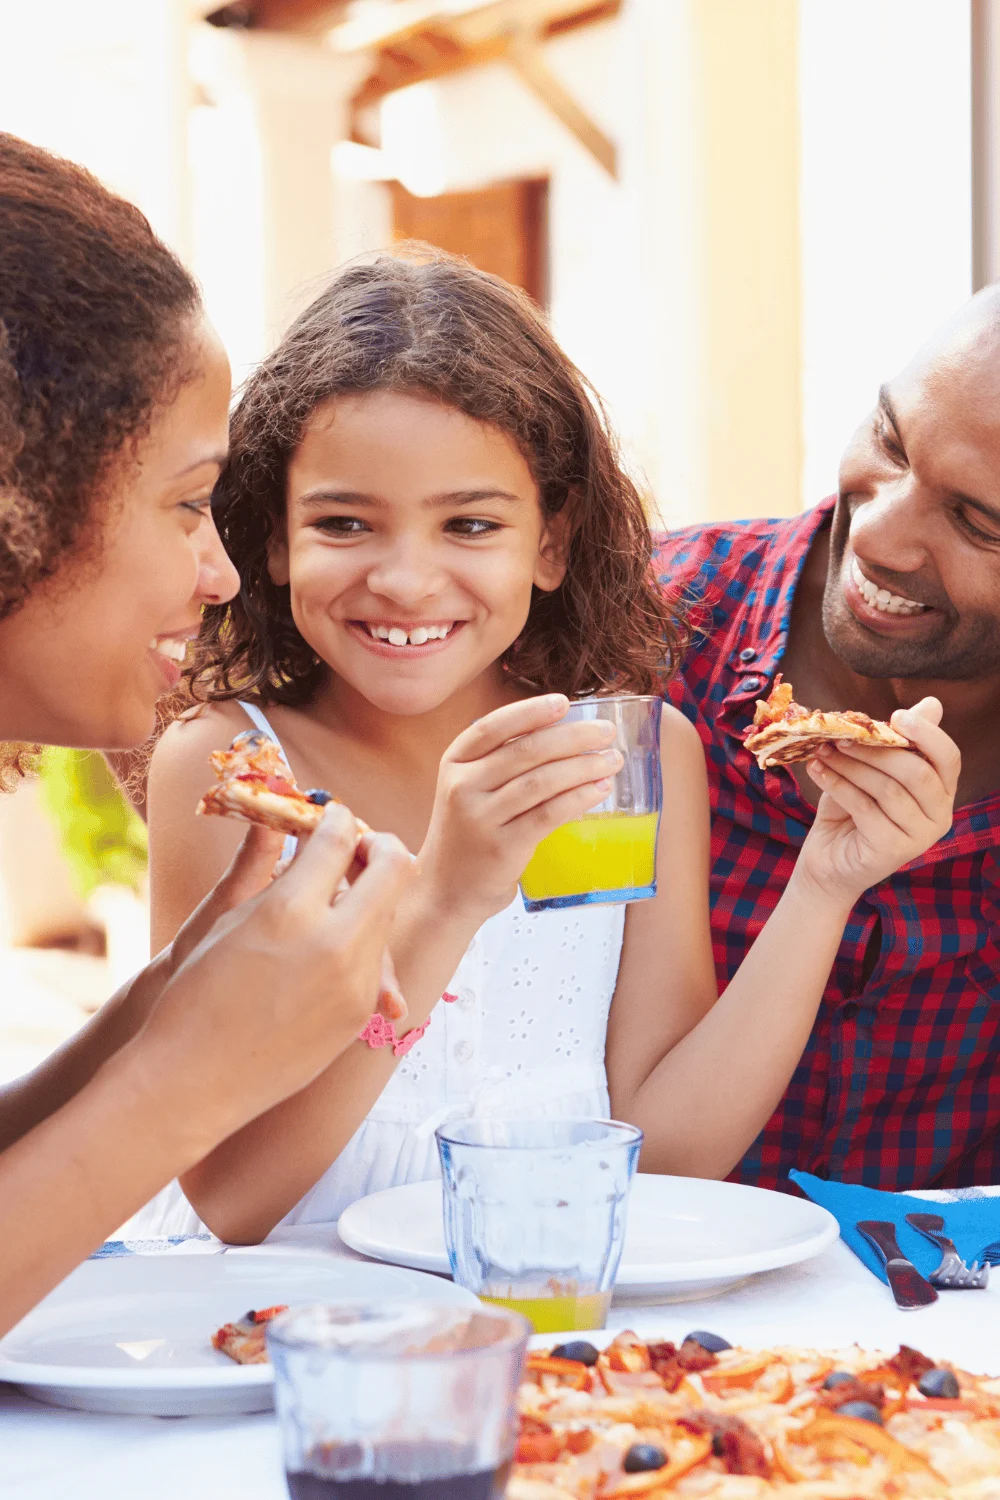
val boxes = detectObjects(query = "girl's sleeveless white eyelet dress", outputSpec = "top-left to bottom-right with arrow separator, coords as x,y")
129,704 -> 625,1236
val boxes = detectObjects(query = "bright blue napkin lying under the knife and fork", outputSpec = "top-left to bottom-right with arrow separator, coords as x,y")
789,1169 -> 1000,1286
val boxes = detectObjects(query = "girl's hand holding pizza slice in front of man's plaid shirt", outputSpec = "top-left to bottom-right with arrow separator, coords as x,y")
796,698 -> 961,906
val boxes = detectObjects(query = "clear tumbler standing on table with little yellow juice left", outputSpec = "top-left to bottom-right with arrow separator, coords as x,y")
436,1119 -> 642,1334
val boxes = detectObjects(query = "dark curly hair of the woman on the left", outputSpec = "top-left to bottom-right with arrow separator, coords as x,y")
0,134 -> 201,786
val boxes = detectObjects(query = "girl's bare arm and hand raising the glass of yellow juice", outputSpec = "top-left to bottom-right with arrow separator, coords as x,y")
150,695 -> 621,1244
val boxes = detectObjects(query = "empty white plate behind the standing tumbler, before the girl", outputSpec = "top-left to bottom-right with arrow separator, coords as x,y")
337,1172 -> 840,1302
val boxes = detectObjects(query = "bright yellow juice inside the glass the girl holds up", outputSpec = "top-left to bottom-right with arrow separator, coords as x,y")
520,813 -> 660,902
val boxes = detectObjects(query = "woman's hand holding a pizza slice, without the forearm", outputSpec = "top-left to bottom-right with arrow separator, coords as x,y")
120,804 -> 414,1151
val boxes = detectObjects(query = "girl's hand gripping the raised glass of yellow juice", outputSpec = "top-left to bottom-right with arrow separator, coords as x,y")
418,693 -> 624,923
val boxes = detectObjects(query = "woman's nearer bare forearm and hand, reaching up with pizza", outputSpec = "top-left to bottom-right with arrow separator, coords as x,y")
0,809 -> 412,1334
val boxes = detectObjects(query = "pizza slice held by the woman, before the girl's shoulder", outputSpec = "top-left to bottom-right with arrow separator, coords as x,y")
198,729 -> 369,837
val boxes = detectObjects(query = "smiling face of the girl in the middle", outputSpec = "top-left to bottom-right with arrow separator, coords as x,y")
268,392 -> 565,714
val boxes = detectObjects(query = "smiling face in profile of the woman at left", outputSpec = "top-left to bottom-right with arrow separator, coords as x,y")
0,323 -> 238,750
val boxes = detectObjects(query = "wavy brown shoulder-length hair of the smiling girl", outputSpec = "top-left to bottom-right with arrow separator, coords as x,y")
189,248 -> 685,705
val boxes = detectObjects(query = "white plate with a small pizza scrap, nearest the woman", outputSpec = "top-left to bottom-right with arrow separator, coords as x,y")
0,1251 -> 475,1416
